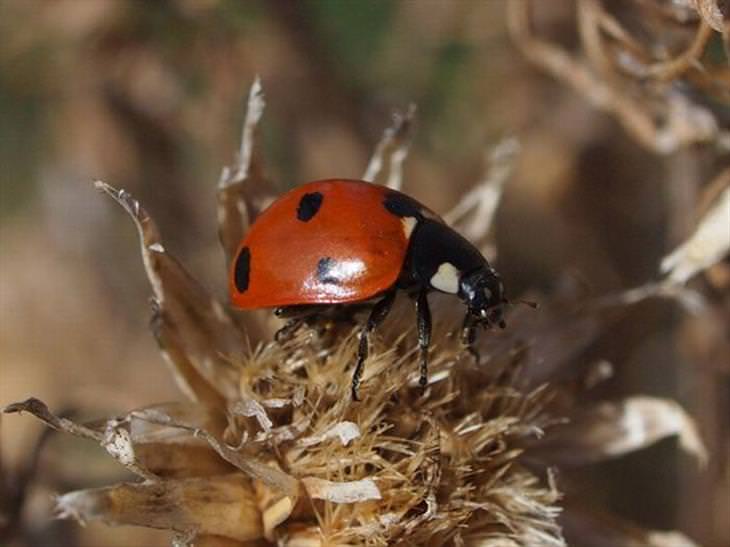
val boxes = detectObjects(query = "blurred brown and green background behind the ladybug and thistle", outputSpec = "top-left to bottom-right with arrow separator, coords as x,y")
0,0 -> 730,546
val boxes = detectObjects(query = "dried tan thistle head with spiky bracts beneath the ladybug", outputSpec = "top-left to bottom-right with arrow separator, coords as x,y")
5,82 -> 706,547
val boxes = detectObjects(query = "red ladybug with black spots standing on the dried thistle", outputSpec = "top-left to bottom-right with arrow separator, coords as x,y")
229,179 -> 507,400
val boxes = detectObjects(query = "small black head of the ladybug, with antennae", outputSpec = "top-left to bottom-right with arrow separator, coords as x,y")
459,266 -> 507,328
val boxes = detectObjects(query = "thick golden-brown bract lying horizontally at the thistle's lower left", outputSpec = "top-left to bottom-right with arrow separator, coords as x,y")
56,473 -> 263,541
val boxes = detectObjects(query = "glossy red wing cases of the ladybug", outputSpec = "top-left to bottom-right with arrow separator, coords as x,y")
229,179 -> 416,308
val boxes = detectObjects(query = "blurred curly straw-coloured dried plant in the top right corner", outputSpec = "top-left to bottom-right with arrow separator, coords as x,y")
507,0 -> 730,154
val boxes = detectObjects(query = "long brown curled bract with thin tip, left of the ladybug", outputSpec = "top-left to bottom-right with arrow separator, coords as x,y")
95,181 -> 243,404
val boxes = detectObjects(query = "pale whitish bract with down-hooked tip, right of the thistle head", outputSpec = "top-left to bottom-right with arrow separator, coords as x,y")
533,396 -> 708,465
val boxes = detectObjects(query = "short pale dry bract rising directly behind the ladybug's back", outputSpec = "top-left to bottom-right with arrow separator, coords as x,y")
362,104 -> 416,190
